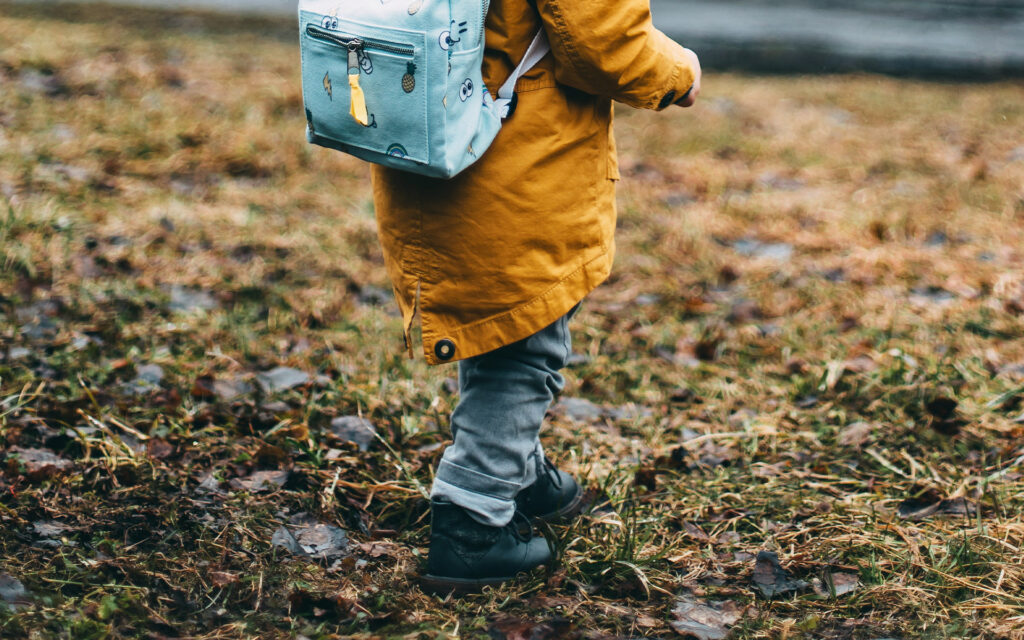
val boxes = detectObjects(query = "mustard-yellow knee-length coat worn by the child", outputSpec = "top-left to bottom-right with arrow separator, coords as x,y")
373,0 -> 693,365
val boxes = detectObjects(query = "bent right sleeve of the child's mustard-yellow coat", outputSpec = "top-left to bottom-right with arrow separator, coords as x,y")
537,0 -> 693,109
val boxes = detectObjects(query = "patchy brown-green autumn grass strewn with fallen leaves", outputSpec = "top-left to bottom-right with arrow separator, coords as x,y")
0,5 -> 1024,639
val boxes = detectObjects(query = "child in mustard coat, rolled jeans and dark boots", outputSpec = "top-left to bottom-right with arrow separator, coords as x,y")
373,0 -> 700,593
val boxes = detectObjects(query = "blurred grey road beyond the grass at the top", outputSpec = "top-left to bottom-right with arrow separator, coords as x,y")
14,0 -> 1024,80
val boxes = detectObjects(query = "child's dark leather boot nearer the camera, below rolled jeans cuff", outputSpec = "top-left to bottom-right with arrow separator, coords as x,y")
420,501 -> 553,595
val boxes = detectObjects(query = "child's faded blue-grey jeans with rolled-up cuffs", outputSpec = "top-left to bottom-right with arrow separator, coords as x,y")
430,305 -> 580,526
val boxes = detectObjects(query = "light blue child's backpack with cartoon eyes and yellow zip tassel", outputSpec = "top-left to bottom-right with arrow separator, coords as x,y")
299,0 -> 550,178
